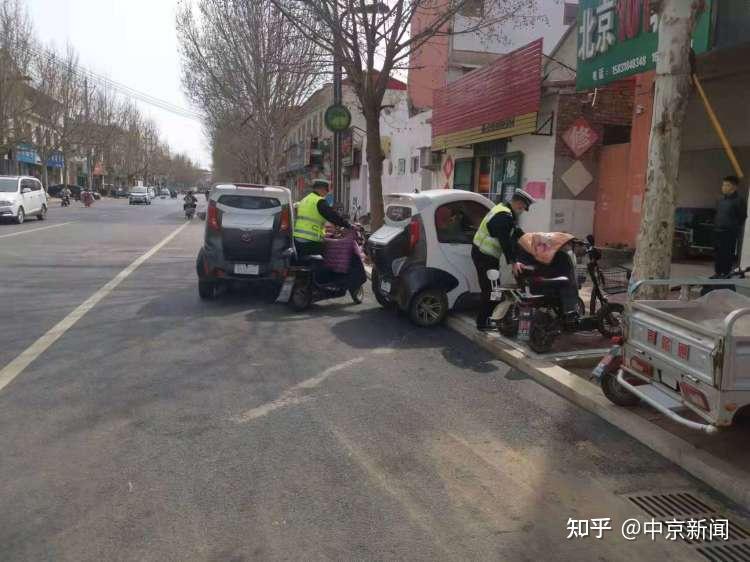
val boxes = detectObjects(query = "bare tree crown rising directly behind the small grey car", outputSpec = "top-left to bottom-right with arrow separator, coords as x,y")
177,0 -> 322,183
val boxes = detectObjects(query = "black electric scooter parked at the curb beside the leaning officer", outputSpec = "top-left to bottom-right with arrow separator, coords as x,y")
487,236 -> 629,353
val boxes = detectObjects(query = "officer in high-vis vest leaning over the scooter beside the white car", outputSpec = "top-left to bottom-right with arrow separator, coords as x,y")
471,189 -> 535,330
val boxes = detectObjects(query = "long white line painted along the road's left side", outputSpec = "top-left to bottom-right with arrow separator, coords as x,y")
0,224 -> 187,391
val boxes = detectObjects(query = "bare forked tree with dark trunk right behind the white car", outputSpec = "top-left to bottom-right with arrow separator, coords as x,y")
271,0 -> 537,228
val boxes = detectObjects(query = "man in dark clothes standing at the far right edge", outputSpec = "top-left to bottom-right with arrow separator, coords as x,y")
714,176 -> 747,275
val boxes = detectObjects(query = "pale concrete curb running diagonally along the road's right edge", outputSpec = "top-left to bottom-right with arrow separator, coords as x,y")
446,316 -> 750,509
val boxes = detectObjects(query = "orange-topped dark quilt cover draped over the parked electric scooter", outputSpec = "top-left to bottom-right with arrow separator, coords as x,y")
513,232 -> 579,328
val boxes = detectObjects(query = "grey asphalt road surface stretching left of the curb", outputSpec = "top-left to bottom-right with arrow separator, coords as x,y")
0,200 -> 740,562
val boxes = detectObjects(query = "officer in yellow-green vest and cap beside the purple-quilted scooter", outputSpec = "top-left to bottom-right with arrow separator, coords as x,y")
294,179 -> 352,256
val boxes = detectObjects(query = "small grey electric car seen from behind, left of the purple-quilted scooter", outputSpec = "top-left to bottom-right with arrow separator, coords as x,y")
196,183 -> 294,299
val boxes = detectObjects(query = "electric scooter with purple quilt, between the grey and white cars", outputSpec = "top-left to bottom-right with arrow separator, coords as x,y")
278,227 -> 367,311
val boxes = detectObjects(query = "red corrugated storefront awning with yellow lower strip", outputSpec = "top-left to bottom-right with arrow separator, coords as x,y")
432,39 -> 542,150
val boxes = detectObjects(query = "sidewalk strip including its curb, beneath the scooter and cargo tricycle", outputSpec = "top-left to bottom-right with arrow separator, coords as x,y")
447,315 -> 750,509
